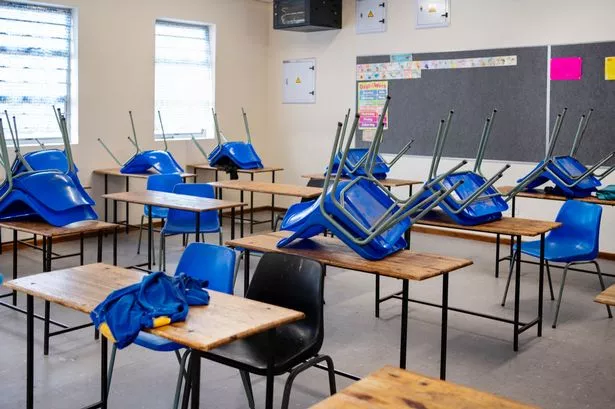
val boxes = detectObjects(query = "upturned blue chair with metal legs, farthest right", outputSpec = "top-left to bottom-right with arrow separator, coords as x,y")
520,108 -> 615,197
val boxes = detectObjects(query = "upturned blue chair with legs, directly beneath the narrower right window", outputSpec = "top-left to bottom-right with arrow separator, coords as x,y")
98,111 -> 184,174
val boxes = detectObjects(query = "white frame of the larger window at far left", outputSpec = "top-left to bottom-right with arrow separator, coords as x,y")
0,0 -> 79,146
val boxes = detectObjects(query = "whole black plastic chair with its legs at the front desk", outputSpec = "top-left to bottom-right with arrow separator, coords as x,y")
203,253 -> 336,409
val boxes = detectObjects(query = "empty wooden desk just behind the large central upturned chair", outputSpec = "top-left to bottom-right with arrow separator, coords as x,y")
210,180 -> 322,234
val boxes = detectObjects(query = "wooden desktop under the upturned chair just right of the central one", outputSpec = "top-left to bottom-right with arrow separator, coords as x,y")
416,211 -> 562,237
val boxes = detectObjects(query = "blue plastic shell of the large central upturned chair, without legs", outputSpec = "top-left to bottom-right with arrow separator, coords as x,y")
277,179 -> 410,260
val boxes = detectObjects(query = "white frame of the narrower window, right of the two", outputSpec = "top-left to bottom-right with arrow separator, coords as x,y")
154,18 -> 217,142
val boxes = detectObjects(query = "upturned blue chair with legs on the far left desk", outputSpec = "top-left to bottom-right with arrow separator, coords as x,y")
0,109 -> 98,226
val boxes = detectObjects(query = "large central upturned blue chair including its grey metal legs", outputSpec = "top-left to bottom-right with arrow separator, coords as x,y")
278,100 -> 464,260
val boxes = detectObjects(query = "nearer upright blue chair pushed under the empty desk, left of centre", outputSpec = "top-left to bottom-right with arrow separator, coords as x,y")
159,183 -> 222,271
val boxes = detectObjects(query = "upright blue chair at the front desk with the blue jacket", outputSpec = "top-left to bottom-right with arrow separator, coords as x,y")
107,243 -> 239,408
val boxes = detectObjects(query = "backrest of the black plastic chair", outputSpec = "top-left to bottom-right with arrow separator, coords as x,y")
246,253 -> 324,352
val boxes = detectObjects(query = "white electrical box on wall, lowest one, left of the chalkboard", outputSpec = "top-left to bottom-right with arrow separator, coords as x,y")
282,58 -> 316,104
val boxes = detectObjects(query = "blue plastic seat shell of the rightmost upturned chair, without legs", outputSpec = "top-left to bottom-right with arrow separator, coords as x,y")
517,156 -> 601,197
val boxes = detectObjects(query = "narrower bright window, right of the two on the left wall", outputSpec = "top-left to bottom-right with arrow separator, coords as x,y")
154,20 -> 214,139
